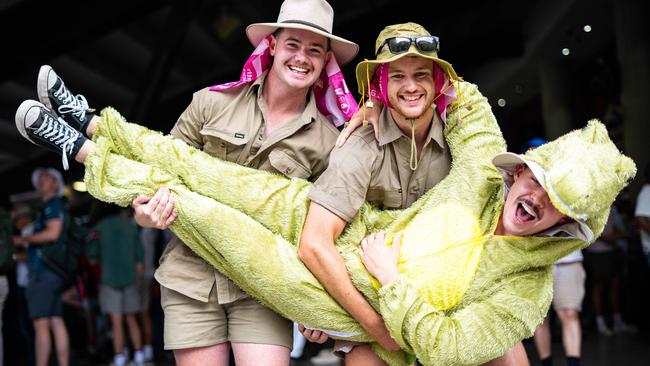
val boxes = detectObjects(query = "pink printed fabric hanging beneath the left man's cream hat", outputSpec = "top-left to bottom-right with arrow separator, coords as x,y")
210,35 -> 359,127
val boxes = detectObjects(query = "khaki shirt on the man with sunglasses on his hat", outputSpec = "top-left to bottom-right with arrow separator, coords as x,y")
309,106 -> 451,222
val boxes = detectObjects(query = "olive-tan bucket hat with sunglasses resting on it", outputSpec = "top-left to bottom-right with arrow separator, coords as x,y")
356,23 -> 461,94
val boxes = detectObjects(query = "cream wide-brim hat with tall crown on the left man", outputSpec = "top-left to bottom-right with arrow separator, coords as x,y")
246,0 -> 359,65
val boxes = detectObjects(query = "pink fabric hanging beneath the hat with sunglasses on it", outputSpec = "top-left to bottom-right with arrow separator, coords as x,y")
369,61 -> 458,122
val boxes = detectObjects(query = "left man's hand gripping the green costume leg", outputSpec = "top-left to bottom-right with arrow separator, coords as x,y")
131,188 -> 178,230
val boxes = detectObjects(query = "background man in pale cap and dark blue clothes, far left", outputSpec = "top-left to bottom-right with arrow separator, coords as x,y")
14,168 -> 70,366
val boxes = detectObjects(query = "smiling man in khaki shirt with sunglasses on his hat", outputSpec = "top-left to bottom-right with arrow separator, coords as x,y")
300,23 -> 525,365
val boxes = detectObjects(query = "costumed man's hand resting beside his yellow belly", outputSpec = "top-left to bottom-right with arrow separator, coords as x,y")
359,232 -> 402,286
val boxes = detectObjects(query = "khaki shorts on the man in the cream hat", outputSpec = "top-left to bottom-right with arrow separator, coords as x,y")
160,286 -> 293,350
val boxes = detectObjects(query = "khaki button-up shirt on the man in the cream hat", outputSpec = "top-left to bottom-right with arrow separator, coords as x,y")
155,71 -> 339,304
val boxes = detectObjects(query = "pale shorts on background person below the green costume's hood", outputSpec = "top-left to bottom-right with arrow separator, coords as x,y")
553,262 -> 585,311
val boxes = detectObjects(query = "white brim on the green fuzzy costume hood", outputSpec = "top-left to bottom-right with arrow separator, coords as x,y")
492,152 -> 594,241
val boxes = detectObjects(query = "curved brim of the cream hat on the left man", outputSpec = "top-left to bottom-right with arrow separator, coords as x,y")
246,23 -> 359,66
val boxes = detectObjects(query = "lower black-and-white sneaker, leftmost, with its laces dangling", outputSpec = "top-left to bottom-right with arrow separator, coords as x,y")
16,100 -> 87,170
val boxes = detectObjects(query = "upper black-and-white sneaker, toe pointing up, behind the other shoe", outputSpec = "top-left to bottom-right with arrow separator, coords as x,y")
37,65 -> 95,135
